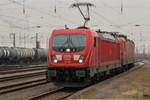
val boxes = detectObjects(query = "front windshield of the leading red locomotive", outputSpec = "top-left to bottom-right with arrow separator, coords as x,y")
52,34 -> 86,52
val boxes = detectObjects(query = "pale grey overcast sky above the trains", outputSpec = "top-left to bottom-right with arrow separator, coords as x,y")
0,0 -> 150,53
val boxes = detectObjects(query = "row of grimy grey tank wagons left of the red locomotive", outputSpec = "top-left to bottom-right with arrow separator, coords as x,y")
0,47 -> 48,64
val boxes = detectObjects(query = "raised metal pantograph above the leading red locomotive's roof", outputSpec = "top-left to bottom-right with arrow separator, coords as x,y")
71,2 -> 94,27
